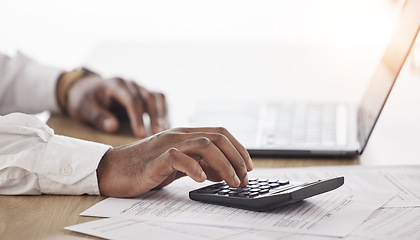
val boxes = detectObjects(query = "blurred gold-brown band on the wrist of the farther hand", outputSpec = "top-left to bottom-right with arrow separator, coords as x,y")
56,68 -> 95,112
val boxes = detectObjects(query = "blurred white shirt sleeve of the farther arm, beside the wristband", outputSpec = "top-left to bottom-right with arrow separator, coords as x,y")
0,53 -> 63,115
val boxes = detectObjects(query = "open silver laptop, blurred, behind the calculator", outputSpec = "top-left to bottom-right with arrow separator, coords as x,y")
191,0 -> 420,157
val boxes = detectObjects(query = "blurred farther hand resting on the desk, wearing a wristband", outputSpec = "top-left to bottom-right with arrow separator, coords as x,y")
66,74 -> 169,138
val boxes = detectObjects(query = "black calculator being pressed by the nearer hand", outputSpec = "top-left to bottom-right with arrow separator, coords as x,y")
189,177 -> 344,211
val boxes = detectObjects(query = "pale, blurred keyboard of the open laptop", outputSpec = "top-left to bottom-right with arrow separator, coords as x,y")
260,103 -> 347,147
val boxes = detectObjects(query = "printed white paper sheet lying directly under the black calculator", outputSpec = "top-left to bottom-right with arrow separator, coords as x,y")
82,169 -> 393,237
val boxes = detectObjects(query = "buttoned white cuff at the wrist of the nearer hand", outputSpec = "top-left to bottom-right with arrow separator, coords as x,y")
37,135 -> 111,195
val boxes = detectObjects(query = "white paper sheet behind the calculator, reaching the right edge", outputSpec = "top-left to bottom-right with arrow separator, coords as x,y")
253,165 -> 420,207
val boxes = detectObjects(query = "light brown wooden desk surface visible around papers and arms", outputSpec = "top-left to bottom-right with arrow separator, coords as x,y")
0,116 -> 359,239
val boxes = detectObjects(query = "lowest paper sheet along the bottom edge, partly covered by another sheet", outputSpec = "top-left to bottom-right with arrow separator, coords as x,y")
66,208 -> 420,240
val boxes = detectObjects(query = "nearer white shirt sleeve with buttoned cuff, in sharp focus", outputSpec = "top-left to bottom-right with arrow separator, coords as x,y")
0,113 -> 111,195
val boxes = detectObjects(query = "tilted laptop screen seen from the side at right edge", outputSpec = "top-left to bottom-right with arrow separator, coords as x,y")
358,0 -> 420,152
